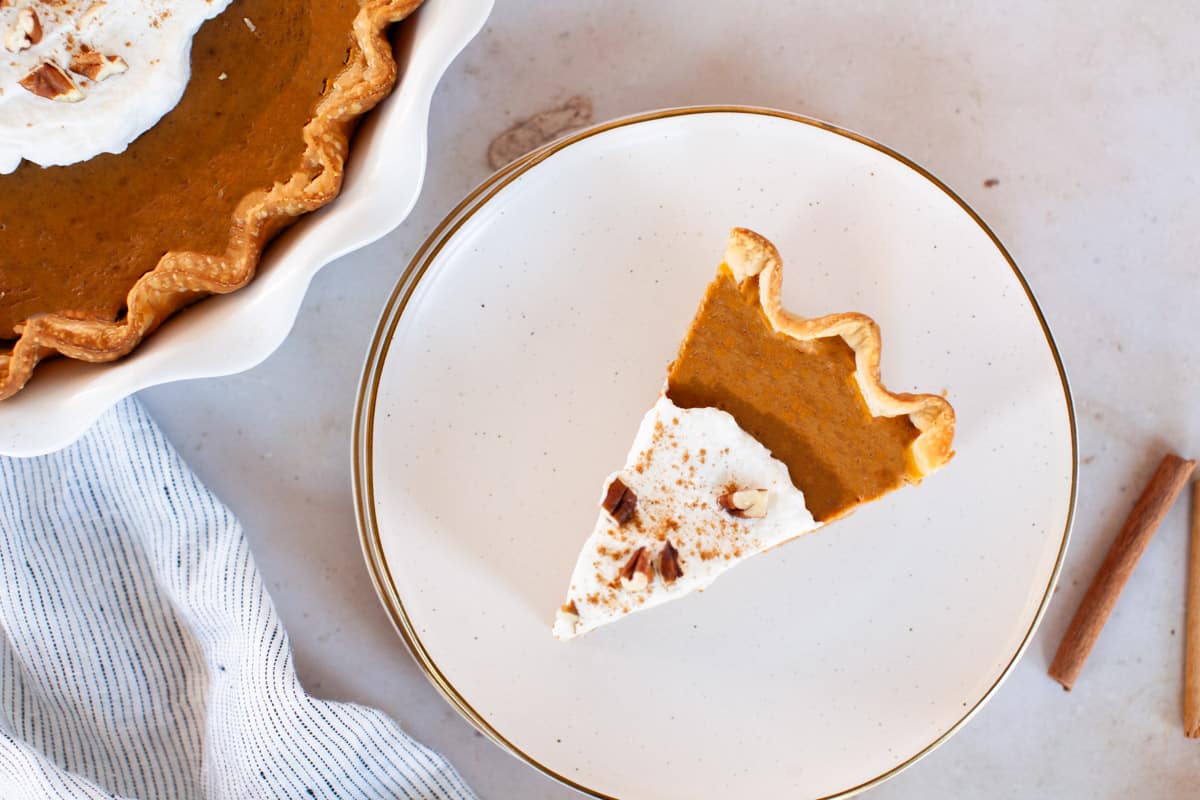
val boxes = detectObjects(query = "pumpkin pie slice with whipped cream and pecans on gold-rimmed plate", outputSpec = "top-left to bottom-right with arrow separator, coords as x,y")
554,228 -> 954,639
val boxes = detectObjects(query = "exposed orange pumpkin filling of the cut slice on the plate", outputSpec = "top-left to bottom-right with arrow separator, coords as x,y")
667,265 -> 918,522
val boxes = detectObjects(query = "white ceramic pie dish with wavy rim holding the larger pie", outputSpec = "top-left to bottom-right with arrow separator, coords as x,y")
0,0 -> 492,456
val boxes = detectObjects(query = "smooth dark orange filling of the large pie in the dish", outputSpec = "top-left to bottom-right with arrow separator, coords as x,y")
0,0 -> 360,338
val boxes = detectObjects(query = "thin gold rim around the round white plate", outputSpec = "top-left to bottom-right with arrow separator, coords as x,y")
353,106 -> 1079,800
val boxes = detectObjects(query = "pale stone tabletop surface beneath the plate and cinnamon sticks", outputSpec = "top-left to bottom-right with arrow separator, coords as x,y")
142,0 -> 1200,799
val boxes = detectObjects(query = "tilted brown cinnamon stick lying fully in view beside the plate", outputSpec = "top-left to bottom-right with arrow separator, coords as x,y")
1049,453 -> 1196,691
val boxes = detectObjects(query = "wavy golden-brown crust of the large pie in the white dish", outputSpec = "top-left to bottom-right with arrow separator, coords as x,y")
0,0 -> 421,399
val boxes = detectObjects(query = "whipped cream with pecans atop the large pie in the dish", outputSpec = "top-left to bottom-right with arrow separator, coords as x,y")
0,0 -> 230,173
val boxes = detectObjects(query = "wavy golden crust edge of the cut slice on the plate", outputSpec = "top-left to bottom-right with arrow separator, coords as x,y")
725,221 -> 954,476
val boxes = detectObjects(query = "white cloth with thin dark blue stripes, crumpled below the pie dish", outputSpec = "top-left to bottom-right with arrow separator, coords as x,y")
0,399 -> 473,800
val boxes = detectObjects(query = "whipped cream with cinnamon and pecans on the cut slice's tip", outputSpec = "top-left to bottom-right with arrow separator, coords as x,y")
554,392 -> 821,639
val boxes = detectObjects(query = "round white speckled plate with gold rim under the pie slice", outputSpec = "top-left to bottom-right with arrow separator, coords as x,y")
355,108 -> 1075,799
